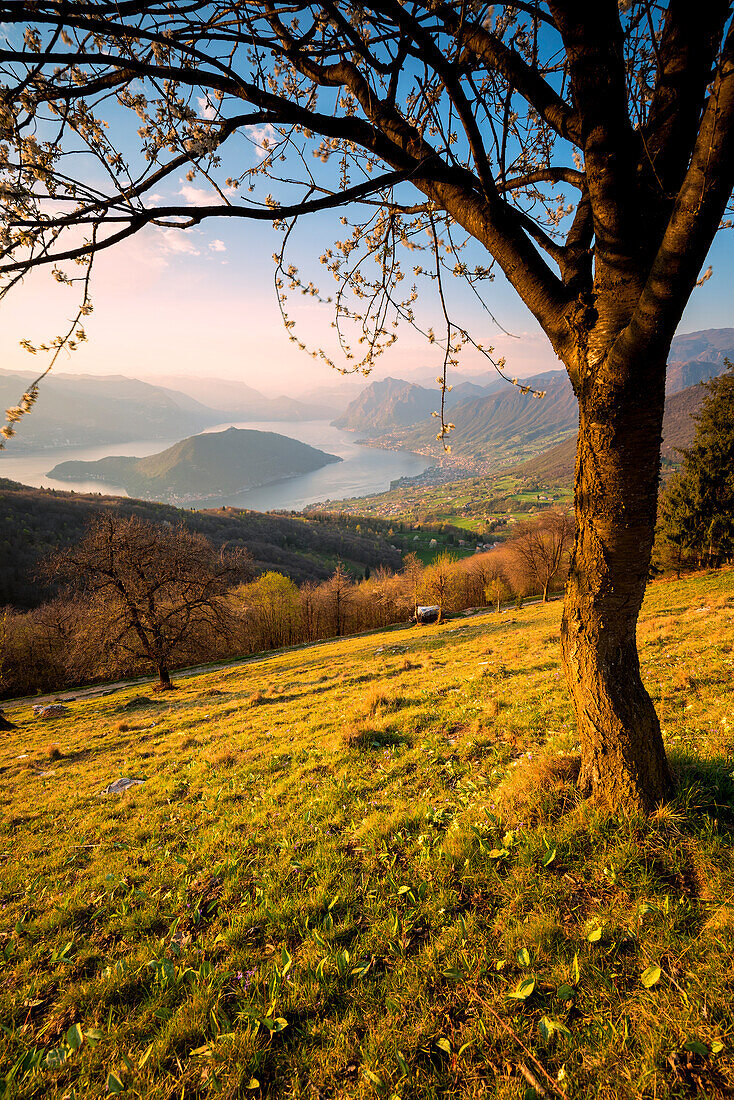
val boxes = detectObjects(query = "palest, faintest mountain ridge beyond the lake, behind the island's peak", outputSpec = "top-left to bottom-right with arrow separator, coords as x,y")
155,374 -> 339,420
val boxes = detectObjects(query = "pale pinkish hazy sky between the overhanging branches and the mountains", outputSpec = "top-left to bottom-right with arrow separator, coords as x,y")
0,195 -> 734,394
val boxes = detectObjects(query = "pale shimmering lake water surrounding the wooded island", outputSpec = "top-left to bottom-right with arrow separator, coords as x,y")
0,420 -> 431,512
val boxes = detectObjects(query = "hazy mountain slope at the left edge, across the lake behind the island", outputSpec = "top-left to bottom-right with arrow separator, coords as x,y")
0,371 -> 221,450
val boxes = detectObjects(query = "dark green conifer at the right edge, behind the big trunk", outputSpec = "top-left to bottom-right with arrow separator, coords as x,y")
660,362 -> 734,571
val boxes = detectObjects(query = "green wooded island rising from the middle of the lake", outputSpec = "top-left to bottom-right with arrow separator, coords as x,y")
48,428 -> 341,504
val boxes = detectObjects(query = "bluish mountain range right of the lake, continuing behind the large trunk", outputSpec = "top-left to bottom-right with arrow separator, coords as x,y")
335,329 -> 734,461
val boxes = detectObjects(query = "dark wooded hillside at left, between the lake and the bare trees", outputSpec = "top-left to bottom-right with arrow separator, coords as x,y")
0,479 -> 402,607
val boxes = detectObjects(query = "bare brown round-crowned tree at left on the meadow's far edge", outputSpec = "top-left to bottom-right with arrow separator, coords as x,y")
48,513 -> 248,689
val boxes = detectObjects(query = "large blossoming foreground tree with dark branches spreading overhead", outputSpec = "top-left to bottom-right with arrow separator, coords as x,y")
0,0 -> 734,810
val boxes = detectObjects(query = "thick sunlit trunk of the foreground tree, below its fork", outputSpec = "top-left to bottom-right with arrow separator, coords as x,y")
561,363 -> 672,813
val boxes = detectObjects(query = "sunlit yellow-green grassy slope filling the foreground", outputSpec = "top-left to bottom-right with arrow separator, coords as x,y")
0,571 -> 734,1100
